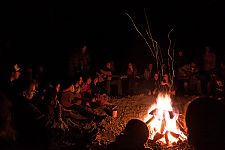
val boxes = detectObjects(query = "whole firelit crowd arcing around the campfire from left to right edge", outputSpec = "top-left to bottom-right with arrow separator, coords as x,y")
0,46 -> 225,150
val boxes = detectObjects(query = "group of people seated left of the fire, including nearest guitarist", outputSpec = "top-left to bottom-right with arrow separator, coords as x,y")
0,61 -> 116,150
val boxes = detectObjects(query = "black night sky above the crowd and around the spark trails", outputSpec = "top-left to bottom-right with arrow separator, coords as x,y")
0,0 -> 225,74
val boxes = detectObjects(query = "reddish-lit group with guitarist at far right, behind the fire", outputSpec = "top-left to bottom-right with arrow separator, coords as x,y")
176,47 -> 225,97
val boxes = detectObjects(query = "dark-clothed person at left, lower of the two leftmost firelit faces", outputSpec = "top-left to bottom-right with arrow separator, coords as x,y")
12,80 -> 48,150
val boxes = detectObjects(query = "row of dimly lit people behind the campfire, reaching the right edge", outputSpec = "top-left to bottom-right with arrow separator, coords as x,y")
68,46 -> 225,98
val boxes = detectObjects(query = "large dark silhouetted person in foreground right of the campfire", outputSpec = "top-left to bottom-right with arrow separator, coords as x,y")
186,97 -> 225,150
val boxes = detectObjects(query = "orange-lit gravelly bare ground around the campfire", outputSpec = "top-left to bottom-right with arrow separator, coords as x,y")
92,95 -> 198,150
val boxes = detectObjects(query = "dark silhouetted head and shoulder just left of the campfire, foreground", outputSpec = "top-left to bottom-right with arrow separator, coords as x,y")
107,119 -> 149,150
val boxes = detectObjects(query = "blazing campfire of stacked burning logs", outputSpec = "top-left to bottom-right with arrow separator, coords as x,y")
144,94 -> 187,145
